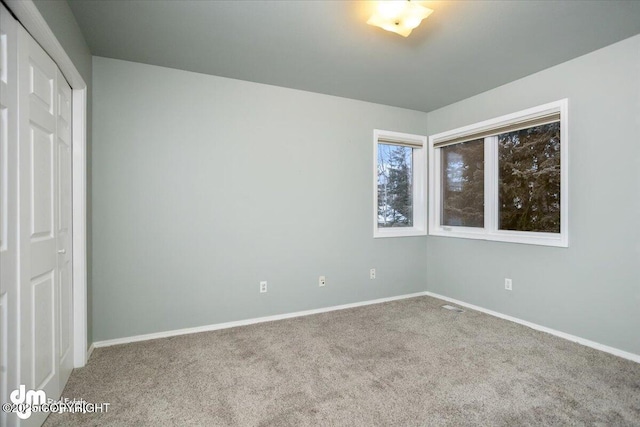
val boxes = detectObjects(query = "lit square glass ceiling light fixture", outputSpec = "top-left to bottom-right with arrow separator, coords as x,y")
367,0 -> 433,37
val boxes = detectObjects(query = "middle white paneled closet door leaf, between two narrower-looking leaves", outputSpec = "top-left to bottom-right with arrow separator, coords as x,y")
18,23 -> 61,426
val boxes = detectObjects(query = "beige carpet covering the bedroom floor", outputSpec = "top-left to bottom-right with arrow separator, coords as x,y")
46,297 -> 640,426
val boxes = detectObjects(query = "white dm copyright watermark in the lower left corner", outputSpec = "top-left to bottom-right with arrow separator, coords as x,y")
2,384 -> 110,420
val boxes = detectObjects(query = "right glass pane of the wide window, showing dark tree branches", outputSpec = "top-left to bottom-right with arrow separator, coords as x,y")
498,122 -> 560,233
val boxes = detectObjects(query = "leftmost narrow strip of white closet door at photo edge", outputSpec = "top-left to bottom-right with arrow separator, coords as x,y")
0,4 -> 19,426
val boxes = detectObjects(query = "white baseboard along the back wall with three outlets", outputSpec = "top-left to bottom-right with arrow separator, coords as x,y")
87,292 -> 427,350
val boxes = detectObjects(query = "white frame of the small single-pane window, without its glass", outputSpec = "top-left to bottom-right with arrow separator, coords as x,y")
373,129 -> 427,238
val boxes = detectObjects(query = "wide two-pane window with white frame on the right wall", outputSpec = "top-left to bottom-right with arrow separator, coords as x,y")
429,99 -> 568,247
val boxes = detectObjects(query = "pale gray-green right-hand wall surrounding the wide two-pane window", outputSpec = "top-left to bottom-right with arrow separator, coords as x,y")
426,36 -> 640,354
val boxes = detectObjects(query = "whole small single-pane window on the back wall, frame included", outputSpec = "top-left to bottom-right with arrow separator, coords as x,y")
373,130 -> 427,237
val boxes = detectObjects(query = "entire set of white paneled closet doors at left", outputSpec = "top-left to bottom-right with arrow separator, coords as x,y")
0,9 -> 73,426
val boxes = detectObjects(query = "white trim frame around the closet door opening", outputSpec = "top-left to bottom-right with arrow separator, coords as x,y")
5,0 -> 93,368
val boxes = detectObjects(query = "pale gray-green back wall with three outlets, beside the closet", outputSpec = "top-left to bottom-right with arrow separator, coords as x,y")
93,57 -> 427,341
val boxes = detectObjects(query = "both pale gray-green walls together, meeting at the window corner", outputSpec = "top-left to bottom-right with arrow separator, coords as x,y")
93,36 -> 640,354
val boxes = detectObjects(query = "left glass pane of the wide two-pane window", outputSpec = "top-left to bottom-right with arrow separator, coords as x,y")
441,139 -> 484,227
